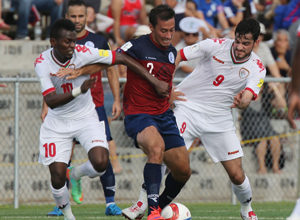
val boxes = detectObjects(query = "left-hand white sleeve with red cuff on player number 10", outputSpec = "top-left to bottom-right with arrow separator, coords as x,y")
34,58 -> 55,96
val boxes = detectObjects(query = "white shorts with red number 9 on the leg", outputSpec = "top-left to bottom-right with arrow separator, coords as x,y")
174,106 -> 244,163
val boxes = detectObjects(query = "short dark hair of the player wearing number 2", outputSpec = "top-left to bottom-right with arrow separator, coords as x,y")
149,5 -> 175,27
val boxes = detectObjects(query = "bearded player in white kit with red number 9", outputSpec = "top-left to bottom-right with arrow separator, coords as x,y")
122,19 -> 266,220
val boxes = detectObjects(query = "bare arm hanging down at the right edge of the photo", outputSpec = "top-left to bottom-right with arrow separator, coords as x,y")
288,36 -> 300,128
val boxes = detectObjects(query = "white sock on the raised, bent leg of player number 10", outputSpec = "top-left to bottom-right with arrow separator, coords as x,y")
71,160 -> 105,180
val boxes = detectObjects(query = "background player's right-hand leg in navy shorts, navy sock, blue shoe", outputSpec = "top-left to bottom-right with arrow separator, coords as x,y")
96,106 -> 122,215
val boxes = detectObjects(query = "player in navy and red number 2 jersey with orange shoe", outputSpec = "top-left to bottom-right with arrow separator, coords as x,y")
55,5 -> 191,220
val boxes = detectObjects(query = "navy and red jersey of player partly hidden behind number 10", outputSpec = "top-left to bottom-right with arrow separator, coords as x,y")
76,31 -> 110,107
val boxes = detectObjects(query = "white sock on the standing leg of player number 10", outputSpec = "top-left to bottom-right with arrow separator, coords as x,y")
50,184 -> 75,220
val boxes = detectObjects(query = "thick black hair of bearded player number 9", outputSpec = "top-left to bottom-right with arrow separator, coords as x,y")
235,18 -> 260,41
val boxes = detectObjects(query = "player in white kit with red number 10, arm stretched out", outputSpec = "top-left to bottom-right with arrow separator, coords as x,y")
35,19 -> 168,220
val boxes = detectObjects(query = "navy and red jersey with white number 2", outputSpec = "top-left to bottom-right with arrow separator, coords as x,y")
121,34 -> 177,115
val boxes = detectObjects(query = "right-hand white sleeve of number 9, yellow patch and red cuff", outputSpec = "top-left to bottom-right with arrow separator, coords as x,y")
245,58 -> 266,100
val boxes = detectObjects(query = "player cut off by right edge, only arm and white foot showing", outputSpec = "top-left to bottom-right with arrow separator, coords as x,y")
287,23 -> 300,220
